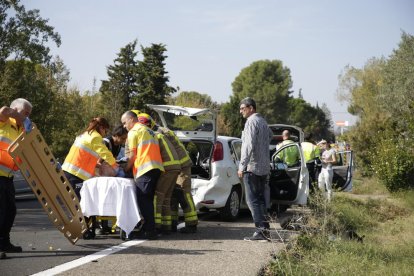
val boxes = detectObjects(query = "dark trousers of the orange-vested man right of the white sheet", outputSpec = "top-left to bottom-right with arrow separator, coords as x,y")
135,169 -> 161,232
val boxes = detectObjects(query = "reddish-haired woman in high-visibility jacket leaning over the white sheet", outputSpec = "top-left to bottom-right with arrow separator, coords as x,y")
62,117 -> 119,199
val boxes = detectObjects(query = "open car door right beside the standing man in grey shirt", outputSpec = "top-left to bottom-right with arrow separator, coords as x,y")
269,143 -> 309,205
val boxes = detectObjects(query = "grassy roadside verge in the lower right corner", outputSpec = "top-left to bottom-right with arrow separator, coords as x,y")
260,180 -> 414,275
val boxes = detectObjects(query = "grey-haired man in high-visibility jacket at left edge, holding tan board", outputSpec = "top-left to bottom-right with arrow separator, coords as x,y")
0,98 -> 32,259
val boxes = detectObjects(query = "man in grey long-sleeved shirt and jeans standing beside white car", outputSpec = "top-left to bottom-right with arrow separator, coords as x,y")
238,98 -> 272,241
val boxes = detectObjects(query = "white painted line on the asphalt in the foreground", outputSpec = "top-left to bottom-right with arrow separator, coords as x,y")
32,240 -> 146,276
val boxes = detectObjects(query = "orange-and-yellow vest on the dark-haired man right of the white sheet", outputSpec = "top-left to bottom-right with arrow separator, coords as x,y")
128,123 -> 164,178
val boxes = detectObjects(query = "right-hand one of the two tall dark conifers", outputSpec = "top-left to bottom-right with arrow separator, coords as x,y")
131,44 -> 176,111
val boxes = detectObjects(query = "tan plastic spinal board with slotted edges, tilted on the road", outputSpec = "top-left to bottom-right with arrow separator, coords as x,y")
8,124 -> 87,244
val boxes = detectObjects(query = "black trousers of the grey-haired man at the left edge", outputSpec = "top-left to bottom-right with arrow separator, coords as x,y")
0,176 -> 16,248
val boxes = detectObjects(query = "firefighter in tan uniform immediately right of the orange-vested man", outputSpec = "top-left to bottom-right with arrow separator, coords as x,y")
138,113 -> 181,234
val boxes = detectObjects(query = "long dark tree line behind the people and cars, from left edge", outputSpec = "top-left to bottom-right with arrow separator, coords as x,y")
0,0 -> 334,161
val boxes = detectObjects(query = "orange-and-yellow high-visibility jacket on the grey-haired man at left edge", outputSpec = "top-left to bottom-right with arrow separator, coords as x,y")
0,118 -> 23,177
